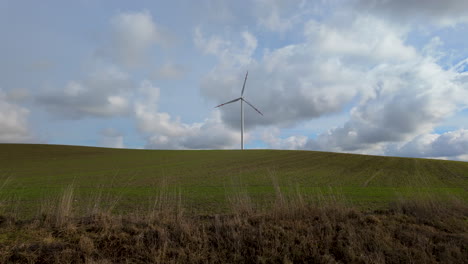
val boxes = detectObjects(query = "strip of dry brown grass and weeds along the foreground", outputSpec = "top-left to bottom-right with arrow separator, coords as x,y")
0,185 -> 468,263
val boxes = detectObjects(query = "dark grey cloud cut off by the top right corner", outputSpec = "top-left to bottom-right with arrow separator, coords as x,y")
352,0 -> 468,26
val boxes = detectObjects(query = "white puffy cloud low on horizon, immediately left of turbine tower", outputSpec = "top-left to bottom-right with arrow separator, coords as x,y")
134,81 -> 239,149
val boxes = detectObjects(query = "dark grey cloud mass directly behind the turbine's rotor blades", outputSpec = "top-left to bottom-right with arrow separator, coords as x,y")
208,65 -> 355,130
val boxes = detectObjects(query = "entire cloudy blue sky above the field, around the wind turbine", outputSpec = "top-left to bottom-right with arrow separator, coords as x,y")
0,0 -> 468,161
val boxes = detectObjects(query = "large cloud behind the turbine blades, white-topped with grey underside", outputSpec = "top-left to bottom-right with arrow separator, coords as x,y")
195,17 -> 417,129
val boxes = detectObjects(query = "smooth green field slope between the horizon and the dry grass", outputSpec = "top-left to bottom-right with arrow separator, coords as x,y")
0,144 -> 468,216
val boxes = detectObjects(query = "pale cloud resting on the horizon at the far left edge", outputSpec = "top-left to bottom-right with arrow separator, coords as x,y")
0,90 -> 35,143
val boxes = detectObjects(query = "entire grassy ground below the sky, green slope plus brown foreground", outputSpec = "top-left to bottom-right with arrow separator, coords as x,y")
0,144 -> 468,263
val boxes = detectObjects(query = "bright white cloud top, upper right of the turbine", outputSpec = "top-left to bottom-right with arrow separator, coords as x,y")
304,16 -> 417,63
